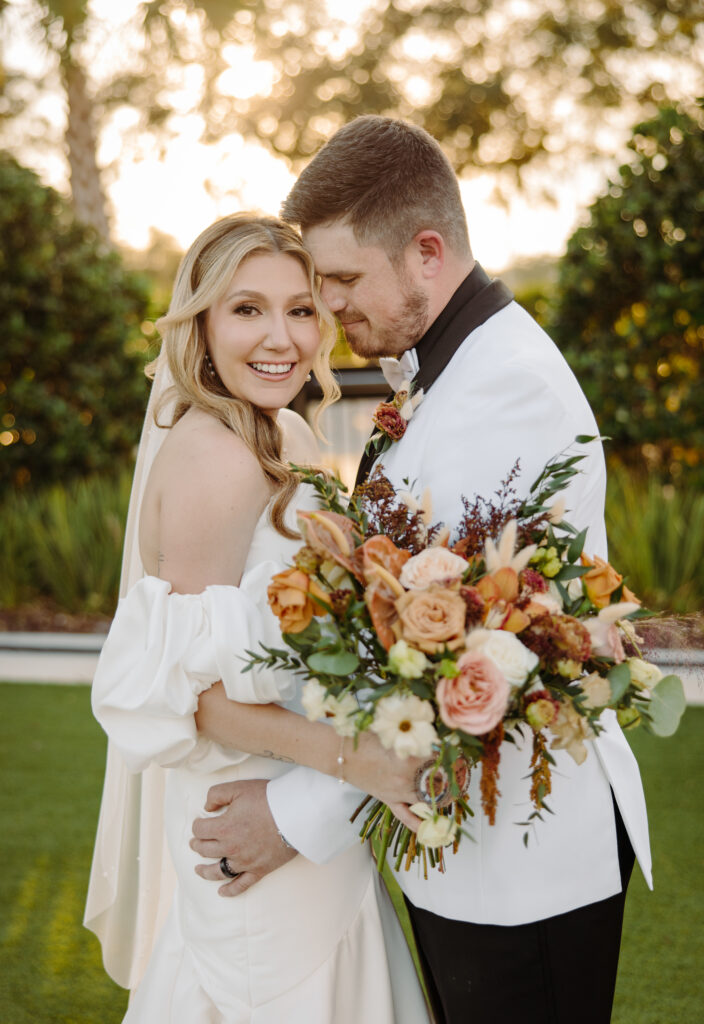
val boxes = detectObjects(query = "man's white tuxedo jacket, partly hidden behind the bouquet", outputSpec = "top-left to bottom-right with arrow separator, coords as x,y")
267,302 -> 652,925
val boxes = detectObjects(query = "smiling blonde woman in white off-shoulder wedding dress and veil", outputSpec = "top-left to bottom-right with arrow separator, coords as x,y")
87,214 -> 428,1024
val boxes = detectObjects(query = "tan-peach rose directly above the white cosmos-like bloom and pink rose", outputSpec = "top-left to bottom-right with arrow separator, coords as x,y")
396,587 -> 467,654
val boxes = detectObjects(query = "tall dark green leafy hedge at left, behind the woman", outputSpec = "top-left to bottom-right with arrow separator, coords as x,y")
0,154 -> 152,485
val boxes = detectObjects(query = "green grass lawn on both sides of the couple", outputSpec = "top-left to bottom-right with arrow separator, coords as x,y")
0,684 -> 704,1024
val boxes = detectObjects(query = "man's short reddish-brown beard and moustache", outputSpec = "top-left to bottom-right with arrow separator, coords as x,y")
339,287 -> 430,359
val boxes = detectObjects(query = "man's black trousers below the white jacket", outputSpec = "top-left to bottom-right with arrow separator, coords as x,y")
406,802 -> 634,1024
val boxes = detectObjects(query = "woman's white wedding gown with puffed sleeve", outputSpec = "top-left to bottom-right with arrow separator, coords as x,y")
93,488 -> 429,1024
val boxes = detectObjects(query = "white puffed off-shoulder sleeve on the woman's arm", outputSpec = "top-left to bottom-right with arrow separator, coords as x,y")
92,561 -> 296,771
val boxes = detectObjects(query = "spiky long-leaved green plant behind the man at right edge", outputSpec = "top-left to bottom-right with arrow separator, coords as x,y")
606,466 -> 704,612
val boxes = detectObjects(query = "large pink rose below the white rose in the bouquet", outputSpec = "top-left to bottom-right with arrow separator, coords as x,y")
436,650 -> 511,736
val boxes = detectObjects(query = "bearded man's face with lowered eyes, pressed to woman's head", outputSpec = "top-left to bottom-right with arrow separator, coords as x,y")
303,221 -> 430,358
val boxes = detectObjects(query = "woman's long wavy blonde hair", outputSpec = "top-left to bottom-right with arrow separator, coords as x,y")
146,213 -> 340,538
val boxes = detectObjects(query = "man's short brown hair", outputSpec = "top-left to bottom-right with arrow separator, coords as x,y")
281,115 -> 470,259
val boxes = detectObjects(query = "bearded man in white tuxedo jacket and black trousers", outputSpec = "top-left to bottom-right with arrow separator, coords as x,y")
191,117 -> 650,1024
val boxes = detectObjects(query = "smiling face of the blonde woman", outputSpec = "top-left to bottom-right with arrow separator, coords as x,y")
206,253 -> 320,413
